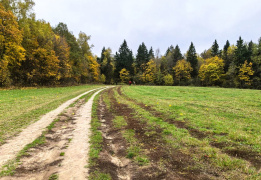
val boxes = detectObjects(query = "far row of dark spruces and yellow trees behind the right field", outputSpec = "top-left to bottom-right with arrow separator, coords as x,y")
98,37 -> 261,89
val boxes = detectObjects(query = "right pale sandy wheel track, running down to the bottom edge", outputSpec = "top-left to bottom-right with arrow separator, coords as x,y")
58,89 -> 107,180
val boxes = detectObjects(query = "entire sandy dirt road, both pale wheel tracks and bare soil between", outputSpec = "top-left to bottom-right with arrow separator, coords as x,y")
0,88 -> 107,180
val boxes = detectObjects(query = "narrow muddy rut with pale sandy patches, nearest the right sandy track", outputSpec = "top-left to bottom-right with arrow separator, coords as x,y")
89,94 -> 132,180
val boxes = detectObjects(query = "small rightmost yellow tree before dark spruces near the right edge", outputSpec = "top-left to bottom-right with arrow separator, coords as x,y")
238,61 -> 254,86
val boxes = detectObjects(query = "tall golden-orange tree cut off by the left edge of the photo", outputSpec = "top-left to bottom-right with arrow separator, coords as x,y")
0,3 -> 25,86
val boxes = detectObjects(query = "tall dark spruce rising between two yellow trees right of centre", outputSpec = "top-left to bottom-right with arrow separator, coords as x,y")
187,42 -> 198,78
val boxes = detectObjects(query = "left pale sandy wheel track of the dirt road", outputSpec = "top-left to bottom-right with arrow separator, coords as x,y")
0,88 -> 103,167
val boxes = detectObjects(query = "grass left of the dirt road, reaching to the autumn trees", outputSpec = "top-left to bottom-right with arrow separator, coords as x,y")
0,85 -> 102,145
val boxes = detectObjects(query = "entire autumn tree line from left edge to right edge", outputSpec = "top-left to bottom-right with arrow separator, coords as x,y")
0,0 -> 261,89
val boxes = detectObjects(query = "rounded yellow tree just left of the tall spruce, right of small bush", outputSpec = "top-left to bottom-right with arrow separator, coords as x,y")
173,59 -> 193,82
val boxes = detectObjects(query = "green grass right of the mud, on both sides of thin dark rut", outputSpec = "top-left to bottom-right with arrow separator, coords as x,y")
117,86 -> 261,179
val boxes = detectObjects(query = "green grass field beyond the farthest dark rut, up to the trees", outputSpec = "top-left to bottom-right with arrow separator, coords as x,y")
123,86 -> 261,150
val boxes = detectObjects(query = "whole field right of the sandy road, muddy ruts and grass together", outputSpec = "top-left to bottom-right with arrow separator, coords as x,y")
90,86 -> 261,179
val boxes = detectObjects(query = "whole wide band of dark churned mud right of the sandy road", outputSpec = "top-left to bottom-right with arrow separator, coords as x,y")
90,89 -> 212,180
